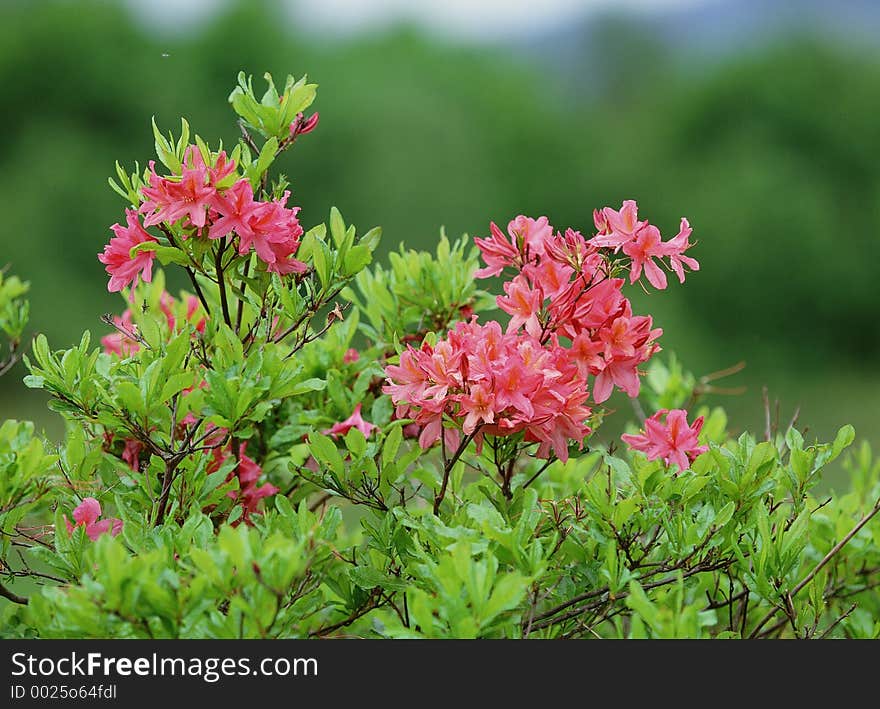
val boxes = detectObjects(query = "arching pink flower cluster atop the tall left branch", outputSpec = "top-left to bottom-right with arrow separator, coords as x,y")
98,145 -> 307,292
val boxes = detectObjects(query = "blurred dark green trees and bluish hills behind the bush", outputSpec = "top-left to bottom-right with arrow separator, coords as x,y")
0,0 -> 880,454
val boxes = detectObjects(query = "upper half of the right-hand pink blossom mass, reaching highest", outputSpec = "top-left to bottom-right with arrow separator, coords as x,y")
475,201 -> 699,403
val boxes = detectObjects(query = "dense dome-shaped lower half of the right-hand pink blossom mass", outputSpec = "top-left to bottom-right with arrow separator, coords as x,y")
383,318 -> 590,460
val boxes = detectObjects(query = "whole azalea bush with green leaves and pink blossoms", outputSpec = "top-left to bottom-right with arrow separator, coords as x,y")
0,74 -> 880,638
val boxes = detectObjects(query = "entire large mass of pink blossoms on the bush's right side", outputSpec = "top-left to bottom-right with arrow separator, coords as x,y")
384,202 -> 699,460
